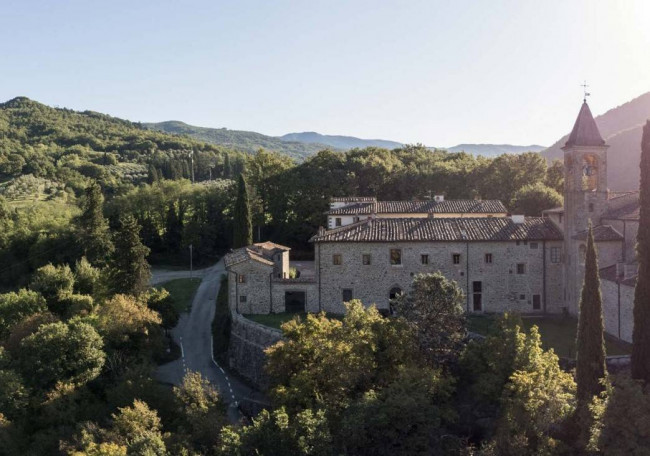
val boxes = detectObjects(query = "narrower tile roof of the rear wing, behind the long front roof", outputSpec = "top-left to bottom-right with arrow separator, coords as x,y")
326,200 -> 508,215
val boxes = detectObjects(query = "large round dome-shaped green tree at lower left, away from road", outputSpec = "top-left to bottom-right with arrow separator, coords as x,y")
18,321 -> 105,390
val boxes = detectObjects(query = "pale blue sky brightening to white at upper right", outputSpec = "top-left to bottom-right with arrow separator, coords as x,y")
0,0 -> 650,147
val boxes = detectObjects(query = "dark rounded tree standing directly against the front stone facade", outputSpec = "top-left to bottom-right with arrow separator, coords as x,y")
394,272 -> 466,362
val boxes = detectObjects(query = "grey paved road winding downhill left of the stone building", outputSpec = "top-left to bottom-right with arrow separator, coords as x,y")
157,261 -> 251,423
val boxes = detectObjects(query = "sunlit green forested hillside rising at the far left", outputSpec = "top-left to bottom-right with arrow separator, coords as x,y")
0,97 -> 243,194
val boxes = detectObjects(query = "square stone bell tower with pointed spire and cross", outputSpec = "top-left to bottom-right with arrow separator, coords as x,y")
562,99 -> 609,315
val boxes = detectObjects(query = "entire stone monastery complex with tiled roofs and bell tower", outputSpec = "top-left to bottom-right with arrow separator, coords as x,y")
225,101 -> 639,341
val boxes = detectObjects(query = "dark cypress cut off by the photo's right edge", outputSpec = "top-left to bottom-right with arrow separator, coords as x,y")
632,121 -> 650,383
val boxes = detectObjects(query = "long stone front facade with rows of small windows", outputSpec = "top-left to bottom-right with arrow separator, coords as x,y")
316,241 -> 563,313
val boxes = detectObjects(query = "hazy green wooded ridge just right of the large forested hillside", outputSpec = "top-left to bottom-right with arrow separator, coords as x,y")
142,120 -> 332,160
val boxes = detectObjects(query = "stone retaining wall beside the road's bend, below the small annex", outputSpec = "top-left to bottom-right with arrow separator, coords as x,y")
228,312 -> 282,391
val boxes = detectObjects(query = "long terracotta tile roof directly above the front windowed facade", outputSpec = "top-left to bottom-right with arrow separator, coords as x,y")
311,217 -> 563,242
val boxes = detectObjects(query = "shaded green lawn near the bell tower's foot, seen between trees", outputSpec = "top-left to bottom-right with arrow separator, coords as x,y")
468,315 -> 631,358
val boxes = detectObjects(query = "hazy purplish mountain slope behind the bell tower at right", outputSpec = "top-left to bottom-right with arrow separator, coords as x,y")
542,92 -> 650,191
